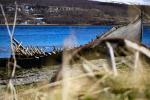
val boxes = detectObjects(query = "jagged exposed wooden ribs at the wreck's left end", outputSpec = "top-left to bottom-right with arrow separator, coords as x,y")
13,38 -> 63,58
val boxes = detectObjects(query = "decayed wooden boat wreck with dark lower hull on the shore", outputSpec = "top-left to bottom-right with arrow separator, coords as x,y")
0,18 -> 142,67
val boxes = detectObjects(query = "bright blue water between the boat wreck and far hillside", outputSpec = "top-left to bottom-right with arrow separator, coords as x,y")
0,26 -> 150,57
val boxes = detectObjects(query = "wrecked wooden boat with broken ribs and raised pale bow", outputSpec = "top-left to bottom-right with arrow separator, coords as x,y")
0,18 -> 142,66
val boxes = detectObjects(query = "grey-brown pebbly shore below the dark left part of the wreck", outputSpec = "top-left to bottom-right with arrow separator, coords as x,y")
0,66 -> 60,85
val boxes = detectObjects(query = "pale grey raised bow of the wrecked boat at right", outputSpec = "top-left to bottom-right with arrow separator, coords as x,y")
99,19 -> 142,43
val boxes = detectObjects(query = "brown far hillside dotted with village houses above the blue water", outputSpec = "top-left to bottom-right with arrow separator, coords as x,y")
0,3 -> 150,25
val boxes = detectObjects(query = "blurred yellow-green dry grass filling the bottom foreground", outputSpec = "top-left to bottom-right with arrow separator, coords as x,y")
0,56 -> 150,100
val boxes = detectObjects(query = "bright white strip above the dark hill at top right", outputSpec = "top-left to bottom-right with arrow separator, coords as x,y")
91,0 -> 150,5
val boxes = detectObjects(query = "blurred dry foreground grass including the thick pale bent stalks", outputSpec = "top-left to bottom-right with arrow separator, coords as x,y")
0,40 -> 150,100
